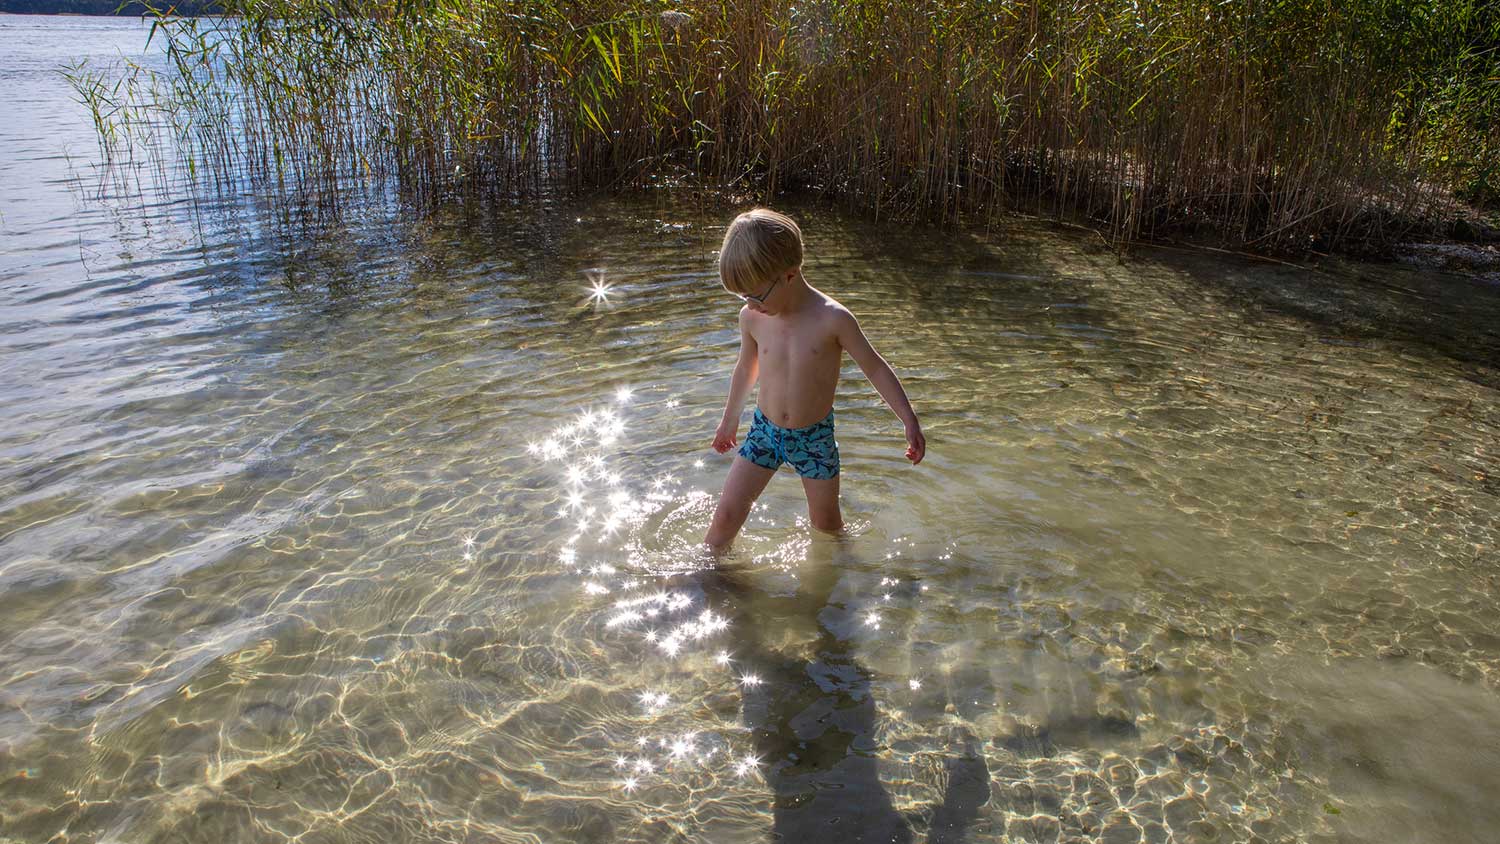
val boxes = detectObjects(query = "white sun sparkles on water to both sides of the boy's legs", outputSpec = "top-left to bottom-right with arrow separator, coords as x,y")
527,401 -> 948,804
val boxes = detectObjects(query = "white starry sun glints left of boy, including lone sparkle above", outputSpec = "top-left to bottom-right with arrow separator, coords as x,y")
527,392 -> 762,799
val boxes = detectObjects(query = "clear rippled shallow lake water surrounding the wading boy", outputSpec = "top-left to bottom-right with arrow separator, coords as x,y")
0,16 -> 1500,844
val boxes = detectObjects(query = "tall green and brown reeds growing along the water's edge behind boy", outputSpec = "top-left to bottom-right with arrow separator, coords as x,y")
75,0 -> 1500,250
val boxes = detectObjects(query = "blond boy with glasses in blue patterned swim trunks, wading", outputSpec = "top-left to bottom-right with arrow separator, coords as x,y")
704,208 -> 927,553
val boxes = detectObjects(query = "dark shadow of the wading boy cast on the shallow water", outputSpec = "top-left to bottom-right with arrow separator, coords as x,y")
701,543 -> 990,844
